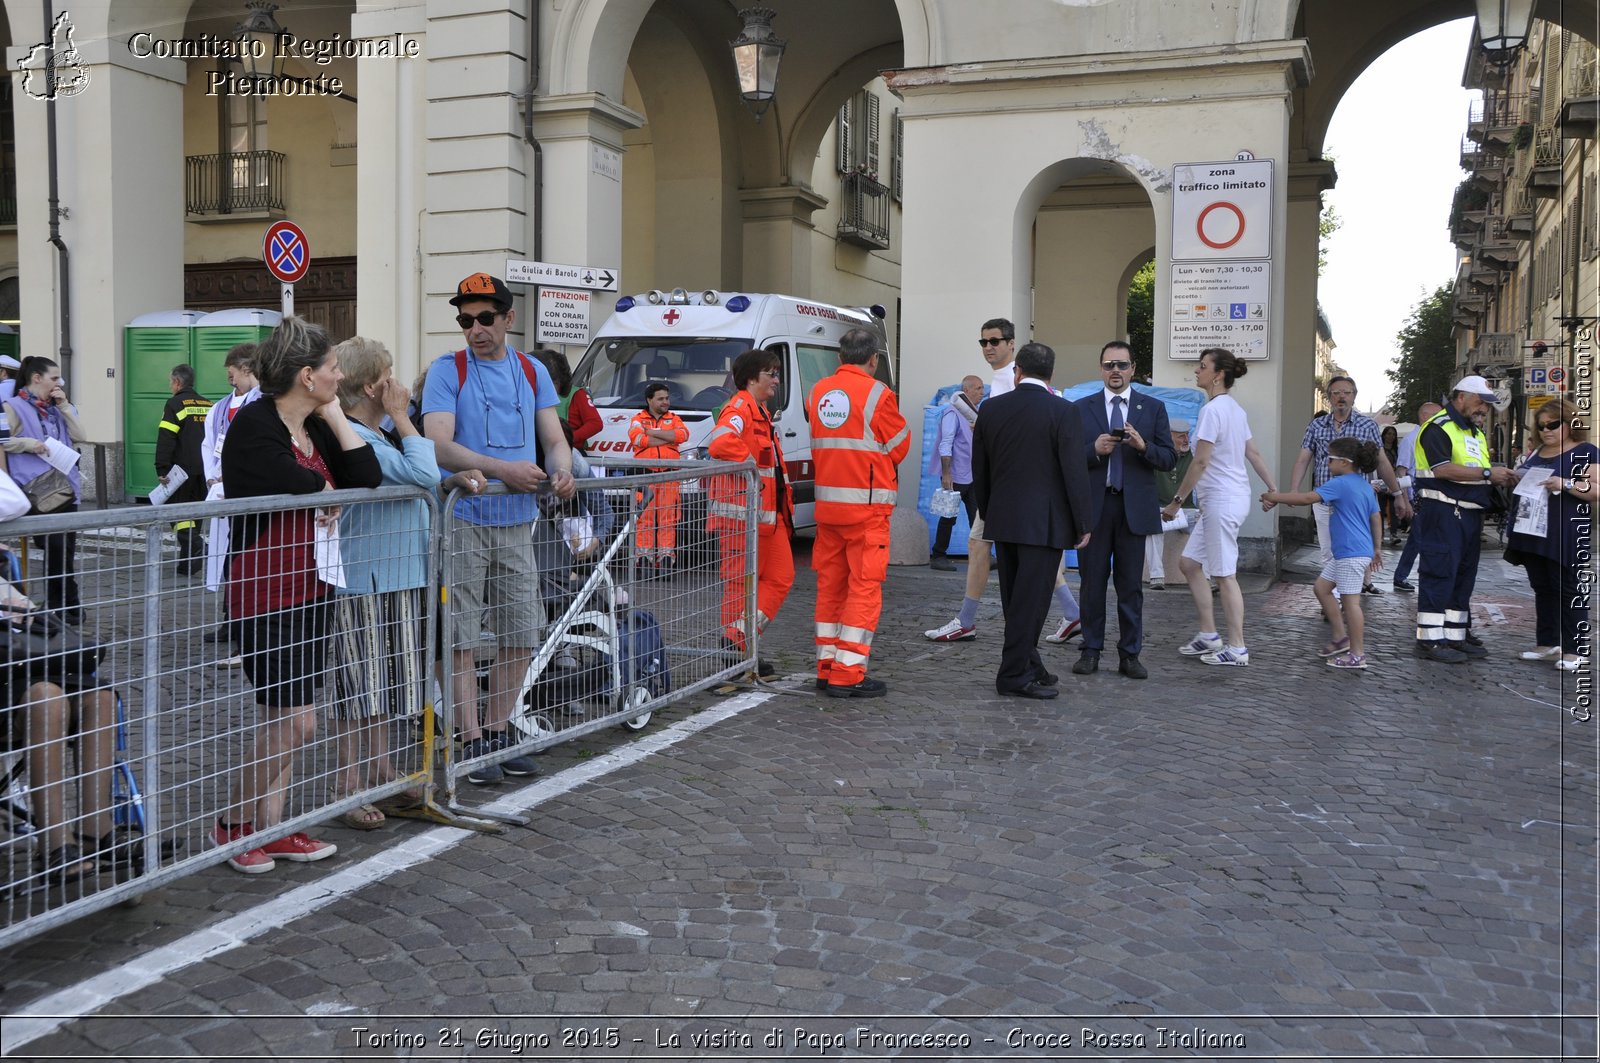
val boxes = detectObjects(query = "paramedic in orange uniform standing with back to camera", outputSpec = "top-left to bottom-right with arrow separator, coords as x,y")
805,328 -> 910,698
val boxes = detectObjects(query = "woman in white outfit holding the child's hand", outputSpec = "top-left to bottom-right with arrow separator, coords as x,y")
1162,347 -> 1278,668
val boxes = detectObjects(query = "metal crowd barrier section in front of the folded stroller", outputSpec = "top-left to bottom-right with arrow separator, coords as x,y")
440,459 -> 760,823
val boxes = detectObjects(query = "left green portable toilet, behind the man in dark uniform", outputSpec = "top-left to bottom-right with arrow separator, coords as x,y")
122,311 -> 205,498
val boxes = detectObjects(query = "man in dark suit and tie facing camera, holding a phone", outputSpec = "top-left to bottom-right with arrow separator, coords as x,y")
1072,339 -> 1178,679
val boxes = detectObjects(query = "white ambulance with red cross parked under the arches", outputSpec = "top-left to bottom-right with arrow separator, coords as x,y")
573,288 -> 893,540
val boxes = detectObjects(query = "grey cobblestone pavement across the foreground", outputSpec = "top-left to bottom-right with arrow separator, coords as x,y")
0,544 -> 1597,1058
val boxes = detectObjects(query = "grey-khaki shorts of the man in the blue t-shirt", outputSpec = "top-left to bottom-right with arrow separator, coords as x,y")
450,523 -> 544,650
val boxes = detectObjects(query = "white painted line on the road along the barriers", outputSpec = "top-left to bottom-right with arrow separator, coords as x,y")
0,692 -> 774,1055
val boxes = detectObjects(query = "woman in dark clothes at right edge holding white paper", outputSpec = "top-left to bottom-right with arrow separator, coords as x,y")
1506,399 -> 1600,672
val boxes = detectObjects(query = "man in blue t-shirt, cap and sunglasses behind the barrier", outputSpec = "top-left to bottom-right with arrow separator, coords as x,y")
422,274 -> 576,786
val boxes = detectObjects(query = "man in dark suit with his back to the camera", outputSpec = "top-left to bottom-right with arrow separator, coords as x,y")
973,343 -> 1090,698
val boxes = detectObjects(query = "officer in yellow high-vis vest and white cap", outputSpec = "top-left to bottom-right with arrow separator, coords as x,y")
1411,369 -> 1517,664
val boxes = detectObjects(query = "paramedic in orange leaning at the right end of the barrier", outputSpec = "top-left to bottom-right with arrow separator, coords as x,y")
706,351 -> 795,676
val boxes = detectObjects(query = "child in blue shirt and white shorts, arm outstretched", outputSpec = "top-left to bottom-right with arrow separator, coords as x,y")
1261,437 -> 1384,668
